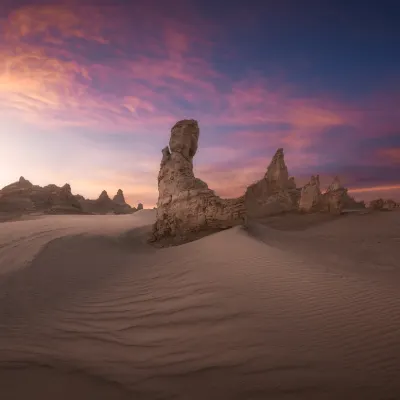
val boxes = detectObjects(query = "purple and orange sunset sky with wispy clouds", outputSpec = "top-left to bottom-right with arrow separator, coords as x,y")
0,0 -> 400,207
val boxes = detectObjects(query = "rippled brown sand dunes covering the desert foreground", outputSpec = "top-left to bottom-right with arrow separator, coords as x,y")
0,211 -> 400,400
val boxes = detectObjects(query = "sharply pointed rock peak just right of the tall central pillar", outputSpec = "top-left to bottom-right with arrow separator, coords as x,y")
245,148 -> 300,218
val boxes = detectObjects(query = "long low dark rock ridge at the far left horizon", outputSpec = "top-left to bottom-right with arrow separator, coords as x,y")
0,176 -> 82,214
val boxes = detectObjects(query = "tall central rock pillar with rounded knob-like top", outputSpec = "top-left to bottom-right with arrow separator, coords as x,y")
150,120 -> 246,241
